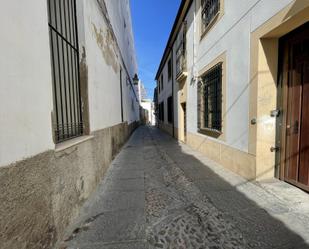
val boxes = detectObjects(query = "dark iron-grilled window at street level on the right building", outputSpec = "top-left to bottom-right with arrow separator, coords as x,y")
198,63 -> 222,132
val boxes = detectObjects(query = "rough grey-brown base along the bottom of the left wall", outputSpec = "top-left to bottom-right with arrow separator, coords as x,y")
0,123 -> 138,249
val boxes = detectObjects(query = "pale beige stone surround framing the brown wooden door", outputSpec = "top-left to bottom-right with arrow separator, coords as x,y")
248,1 -> 309,180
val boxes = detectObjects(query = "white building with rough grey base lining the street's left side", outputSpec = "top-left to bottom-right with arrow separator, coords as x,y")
0,0 -> 139,249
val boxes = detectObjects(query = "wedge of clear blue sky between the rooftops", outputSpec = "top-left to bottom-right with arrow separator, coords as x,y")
130,0 -> 181,99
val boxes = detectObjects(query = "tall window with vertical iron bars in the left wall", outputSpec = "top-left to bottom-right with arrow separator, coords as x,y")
47,0 -> 83,143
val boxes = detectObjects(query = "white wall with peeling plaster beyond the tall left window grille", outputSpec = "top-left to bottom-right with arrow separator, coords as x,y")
84,0 -> 138,131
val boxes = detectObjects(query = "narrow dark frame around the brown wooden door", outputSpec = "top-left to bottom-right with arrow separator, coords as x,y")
276,22 -> 309,192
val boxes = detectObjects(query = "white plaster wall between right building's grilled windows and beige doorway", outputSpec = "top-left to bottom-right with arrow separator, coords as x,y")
188,0 -> 292,152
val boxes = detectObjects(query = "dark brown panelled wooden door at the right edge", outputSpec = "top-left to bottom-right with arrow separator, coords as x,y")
282,25 -> 309,189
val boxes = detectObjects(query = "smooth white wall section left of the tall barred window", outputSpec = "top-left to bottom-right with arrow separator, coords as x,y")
0,0 -> 54,166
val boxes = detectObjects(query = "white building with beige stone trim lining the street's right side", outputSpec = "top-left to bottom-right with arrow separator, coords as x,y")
156,0 -> 309,190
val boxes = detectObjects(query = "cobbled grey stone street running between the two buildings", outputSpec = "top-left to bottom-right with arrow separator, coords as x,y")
59,127 -> 309,249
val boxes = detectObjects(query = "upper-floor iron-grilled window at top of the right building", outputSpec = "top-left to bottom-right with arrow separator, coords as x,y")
201,0 -> 220,32
